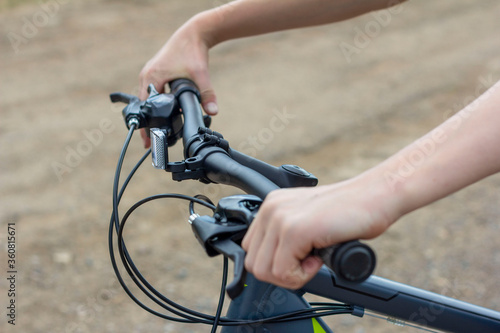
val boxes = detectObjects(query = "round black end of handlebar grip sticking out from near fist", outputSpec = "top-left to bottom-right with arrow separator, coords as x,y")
313,241 -> 376,282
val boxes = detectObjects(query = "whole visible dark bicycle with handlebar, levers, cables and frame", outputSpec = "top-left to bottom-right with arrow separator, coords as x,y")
108,80 -> 500,332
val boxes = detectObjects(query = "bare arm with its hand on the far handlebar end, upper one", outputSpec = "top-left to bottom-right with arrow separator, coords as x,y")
139,0 -> 402,147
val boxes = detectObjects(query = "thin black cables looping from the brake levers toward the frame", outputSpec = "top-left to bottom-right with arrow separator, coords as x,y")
108,123 -> 366,333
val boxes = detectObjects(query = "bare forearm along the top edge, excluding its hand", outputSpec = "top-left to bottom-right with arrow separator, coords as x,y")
188,0 -> 403,46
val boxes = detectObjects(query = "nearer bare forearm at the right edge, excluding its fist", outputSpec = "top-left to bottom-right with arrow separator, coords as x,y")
365,82 -> 500,216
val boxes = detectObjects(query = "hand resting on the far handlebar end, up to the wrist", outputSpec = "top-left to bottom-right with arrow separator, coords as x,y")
139,15 -> 218,148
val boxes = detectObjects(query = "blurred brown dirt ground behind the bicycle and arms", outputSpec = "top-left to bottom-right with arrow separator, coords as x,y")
0,0 -> 500,333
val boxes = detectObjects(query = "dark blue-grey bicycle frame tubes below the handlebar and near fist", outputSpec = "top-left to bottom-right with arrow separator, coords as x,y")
222,267 -> 500,333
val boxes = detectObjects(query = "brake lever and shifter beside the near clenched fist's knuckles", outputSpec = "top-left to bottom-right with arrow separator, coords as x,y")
189,195 -> 262,299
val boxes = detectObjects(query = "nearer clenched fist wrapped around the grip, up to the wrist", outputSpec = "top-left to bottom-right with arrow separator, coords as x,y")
242,179 -> 396,289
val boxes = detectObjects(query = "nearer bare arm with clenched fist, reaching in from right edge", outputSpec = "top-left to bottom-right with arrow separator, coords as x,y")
242,82 -> 500,288
